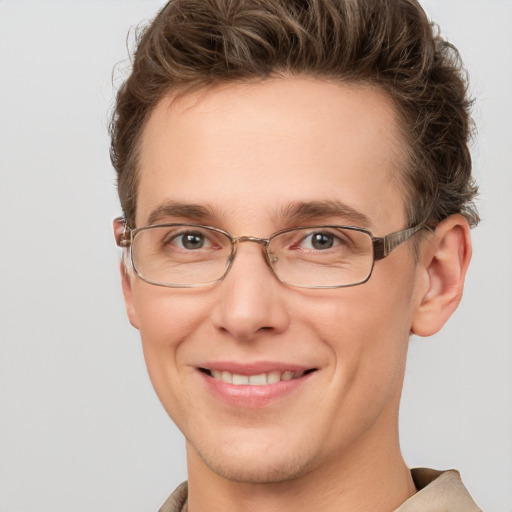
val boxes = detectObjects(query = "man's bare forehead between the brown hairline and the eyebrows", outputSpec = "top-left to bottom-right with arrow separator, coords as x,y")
137,77 -> 405,234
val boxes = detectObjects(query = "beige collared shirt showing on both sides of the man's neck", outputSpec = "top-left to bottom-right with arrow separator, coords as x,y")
158,468 -> 482,512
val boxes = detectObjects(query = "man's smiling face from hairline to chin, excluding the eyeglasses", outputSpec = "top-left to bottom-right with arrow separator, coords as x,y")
124,78 -> 419,482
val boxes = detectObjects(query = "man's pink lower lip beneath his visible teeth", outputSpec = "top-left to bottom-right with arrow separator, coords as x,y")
199,371 -> 316,408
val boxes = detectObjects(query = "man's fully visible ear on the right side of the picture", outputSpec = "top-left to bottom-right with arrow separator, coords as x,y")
411,214 -> 471,336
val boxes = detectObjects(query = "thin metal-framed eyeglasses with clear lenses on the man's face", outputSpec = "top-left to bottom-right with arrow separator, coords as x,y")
115,218 -> 430,288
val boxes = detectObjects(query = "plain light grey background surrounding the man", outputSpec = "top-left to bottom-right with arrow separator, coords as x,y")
0,0 -> 512,512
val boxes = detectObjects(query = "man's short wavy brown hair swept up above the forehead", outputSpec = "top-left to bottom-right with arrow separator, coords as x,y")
110,0 -> 478,226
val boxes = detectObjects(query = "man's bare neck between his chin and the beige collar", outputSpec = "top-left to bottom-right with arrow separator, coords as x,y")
187,435 -> 416,512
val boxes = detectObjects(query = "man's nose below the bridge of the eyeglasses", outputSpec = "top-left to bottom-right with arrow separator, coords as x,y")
213,240 -> 290,341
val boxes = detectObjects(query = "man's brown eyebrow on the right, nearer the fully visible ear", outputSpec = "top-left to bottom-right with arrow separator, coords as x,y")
279,200 -> 371,228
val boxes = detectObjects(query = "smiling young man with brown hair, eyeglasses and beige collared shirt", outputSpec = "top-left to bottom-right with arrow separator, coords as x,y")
112,0 -> 479,512
